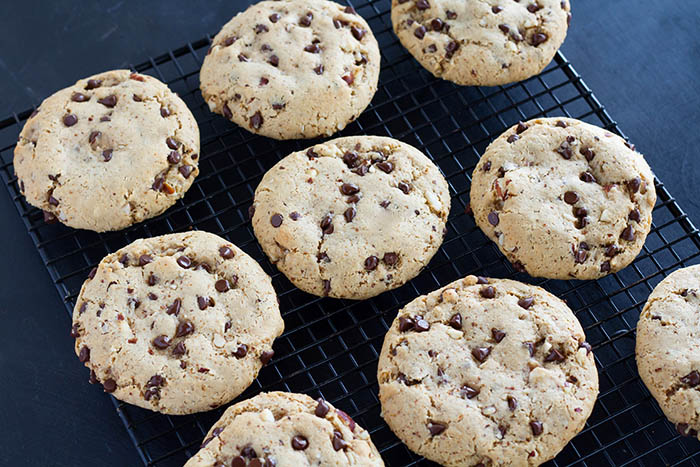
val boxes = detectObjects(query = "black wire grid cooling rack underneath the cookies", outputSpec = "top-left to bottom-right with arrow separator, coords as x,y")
0,0 -> 700,466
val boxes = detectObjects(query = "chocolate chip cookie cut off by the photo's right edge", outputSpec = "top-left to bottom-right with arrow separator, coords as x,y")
636,266 -> 700,437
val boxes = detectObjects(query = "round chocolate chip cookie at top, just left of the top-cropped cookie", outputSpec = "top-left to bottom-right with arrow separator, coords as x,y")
200,0 -> 380,139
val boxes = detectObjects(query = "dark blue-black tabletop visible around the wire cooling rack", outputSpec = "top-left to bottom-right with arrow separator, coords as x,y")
0,0 -> 700,466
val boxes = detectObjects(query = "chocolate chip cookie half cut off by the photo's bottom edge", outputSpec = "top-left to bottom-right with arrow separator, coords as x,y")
185,392 -> 384,467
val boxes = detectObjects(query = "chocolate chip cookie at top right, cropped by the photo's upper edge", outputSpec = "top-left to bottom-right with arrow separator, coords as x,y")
391,0 -> 571,86
